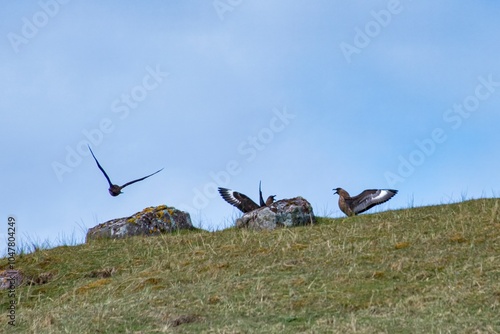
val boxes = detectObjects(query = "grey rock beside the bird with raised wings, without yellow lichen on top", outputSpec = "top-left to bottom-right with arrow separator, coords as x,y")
236,197 -> 315,230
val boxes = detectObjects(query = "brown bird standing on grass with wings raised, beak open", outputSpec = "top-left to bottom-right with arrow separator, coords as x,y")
333,188 -> 398,216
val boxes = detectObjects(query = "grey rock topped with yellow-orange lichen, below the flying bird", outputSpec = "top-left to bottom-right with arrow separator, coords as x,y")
86,205 -> 194,242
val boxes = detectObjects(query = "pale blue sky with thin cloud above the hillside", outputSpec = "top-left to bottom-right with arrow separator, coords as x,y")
0,0 -> 500,254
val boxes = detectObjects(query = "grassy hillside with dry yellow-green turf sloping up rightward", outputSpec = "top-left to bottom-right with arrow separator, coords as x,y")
0,199 -> 500,333
